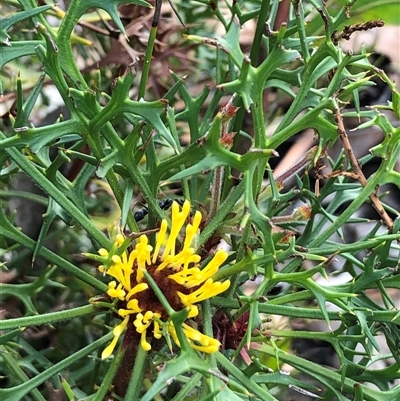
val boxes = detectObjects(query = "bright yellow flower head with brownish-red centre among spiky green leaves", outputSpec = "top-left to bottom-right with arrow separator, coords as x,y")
99,201 -> 230,359
